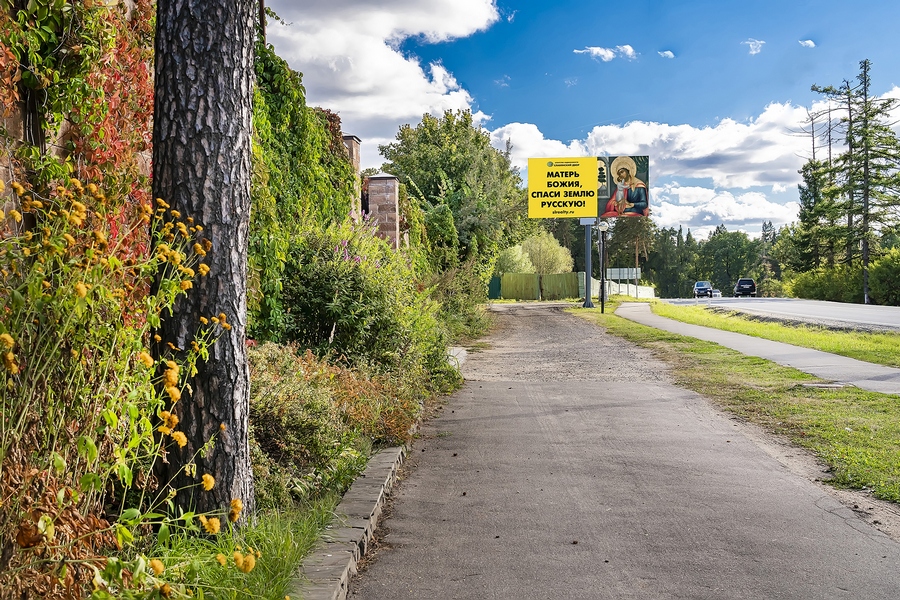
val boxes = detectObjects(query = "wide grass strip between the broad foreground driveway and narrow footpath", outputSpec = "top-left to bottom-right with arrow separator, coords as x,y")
574,305 -> 900,502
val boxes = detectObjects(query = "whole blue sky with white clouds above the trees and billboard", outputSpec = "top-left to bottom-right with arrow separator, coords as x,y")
268,0 -> 900,237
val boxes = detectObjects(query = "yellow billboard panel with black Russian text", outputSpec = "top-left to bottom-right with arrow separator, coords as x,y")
528,156 -> 598,219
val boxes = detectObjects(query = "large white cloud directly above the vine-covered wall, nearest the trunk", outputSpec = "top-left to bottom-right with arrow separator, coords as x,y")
267,0 -> 500,166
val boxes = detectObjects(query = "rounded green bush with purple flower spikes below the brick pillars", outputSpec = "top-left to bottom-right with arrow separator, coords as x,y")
280,221 -> 458,390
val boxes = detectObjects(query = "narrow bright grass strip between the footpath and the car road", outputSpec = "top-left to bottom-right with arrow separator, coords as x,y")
651,302 -> 900,367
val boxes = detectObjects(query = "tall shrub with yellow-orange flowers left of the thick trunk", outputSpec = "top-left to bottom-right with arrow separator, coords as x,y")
0,180 -> 219,598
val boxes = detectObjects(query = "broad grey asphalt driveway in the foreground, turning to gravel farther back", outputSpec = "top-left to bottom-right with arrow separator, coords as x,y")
351,304 -> 900,600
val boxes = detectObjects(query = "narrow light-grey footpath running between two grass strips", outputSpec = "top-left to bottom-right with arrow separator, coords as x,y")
616,302 -> 900,394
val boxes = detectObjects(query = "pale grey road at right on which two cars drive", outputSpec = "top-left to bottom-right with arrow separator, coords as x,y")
665,297 -> 900,331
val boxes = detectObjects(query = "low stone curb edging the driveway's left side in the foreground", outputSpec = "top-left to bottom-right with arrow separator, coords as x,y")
288,447 -> 407,600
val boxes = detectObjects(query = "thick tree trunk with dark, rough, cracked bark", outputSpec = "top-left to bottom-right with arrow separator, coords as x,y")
153,0 -> 257,514
